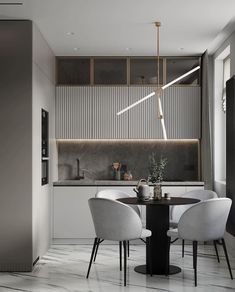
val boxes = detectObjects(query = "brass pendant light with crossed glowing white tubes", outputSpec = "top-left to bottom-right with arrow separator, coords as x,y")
117,22 -> 200,140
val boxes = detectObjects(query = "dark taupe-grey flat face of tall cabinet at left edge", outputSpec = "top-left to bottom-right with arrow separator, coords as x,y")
0,20 -> 32,270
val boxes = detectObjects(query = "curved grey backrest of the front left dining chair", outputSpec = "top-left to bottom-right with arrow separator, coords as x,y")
88,198 -> 142,241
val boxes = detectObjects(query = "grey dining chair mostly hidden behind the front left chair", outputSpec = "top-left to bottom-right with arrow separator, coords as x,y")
94,189 -> 141,271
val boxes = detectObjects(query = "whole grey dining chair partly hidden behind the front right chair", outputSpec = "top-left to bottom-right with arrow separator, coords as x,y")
170,190 -> 219,256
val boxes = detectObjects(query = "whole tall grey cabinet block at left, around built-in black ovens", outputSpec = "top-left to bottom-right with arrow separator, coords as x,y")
0,20 -> 55,271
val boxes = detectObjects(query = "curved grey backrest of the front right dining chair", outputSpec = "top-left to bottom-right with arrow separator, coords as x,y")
178,198 -> 232,241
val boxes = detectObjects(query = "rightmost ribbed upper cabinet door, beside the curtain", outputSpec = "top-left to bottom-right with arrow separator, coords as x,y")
162,86 -> 201,139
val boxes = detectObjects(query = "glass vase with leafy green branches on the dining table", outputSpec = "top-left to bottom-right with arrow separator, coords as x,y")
148,153 -> 167,200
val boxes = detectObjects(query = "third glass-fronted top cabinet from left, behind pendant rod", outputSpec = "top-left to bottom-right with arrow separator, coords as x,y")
130,57 -> 163,85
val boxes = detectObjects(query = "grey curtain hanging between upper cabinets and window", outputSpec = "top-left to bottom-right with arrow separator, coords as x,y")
201,51 -> 213,190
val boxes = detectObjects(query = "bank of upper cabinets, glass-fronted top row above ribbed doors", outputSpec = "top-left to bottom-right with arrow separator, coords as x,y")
56,57 -> 201,139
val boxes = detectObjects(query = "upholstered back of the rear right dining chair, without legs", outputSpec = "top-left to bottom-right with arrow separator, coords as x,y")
171,190 -> 218,223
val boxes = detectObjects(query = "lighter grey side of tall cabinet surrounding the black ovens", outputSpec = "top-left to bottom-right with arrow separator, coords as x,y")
32,25 -> 57,260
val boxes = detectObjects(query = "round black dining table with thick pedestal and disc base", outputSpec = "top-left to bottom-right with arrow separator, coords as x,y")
118,197 -> 200,275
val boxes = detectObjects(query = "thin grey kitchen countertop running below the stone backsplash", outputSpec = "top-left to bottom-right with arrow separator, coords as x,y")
53,179 -> 204,186
